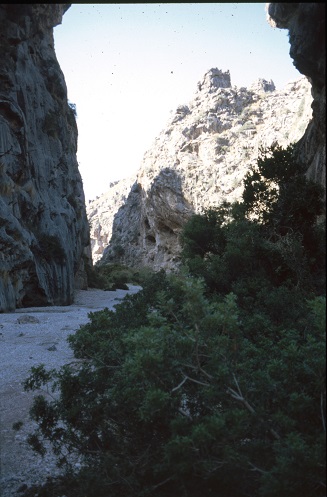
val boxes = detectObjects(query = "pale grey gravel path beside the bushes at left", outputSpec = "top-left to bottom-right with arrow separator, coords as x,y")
0,285 -> 140,497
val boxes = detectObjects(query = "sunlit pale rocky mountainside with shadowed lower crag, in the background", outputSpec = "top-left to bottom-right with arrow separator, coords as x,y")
87,68 -> 312,270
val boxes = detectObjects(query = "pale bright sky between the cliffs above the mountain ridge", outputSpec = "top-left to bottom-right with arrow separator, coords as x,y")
54,3 -> 302,201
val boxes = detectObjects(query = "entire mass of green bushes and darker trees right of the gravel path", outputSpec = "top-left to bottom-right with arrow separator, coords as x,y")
21,144 -> 326,497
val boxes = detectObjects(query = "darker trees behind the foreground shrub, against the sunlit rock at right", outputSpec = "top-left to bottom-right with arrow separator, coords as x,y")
181,146 -> 325,298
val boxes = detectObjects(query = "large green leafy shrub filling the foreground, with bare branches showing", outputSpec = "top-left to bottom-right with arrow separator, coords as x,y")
22,274 -> 325,497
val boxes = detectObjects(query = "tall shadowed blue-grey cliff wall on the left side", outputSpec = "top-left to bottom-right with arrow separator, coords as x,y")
0,4 -> 90,311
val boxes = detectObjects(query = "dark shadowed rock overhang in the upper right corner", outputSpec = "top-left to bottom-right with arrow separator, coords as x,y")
266,3 -> 326,193
